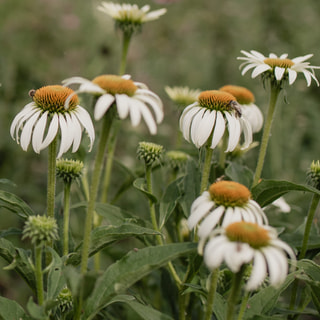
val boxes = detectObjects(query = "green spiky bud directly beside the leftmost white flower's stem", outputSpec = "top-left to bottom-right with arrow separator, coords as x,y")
56,159 -> 83,184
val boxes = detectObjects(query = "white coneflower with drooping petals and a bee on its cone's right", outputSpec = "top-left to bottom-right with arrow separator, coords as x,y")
180,90 -> 252,152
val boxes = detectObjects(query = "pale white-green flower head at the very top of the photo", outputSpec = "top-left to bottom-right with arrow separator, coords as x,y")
98,2 -> 167,34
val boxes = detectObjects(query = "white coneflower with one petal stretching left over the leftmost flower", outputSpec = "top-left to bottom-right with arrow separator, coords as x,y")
63,75 -> 163,134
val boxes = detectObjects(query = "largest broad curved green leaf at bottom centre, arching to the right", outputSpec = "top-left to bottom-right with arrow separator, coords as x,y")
84,243 -> 197,319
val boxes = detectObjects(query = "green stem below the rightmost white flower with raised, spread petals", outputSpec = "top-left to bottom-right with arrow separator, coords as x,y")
252,86 -> 281,187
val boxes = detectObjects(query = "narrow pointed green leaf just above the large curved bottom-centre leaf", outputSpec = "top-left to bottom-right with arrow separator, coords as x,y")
89,223 -> 161,256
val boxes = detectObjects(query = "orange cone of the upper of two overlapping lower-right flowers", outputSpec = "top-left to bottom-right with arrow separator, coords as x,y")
209,181 -> 251,207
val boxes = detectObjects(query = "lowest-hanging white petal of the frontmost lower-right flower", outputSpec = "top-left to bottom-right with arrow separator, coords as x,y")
246,250 -> 267,291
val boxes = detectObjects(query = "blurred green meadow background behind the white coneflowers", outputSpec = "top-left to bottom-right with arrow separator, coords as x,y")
0,0 -> 320,308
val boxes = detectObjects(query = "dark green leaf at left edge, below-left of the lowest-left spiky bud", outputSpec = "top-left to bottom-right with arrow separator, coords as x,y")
0,238 -> 36,291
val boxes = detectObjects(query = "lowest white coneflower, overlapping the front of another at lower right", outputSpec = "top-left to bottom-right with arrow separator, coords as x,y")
204,221 -> 296,291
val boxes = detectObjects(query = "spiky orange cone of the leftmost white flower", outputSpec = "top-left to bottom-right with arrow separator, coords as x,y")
31,85 -> 79,113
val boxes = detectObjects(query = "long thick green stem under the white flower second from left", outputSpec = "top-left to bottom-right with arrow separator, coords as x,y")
81,111 -> 114,274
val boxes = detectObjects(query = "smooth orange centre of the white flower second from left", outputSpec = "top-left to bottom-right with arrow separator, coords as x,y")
92,74 -> 138,97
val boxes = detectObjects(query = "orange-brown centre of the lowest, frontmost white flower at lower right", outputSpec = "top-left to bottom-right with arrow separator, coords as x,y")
225,221 -> 270,249
